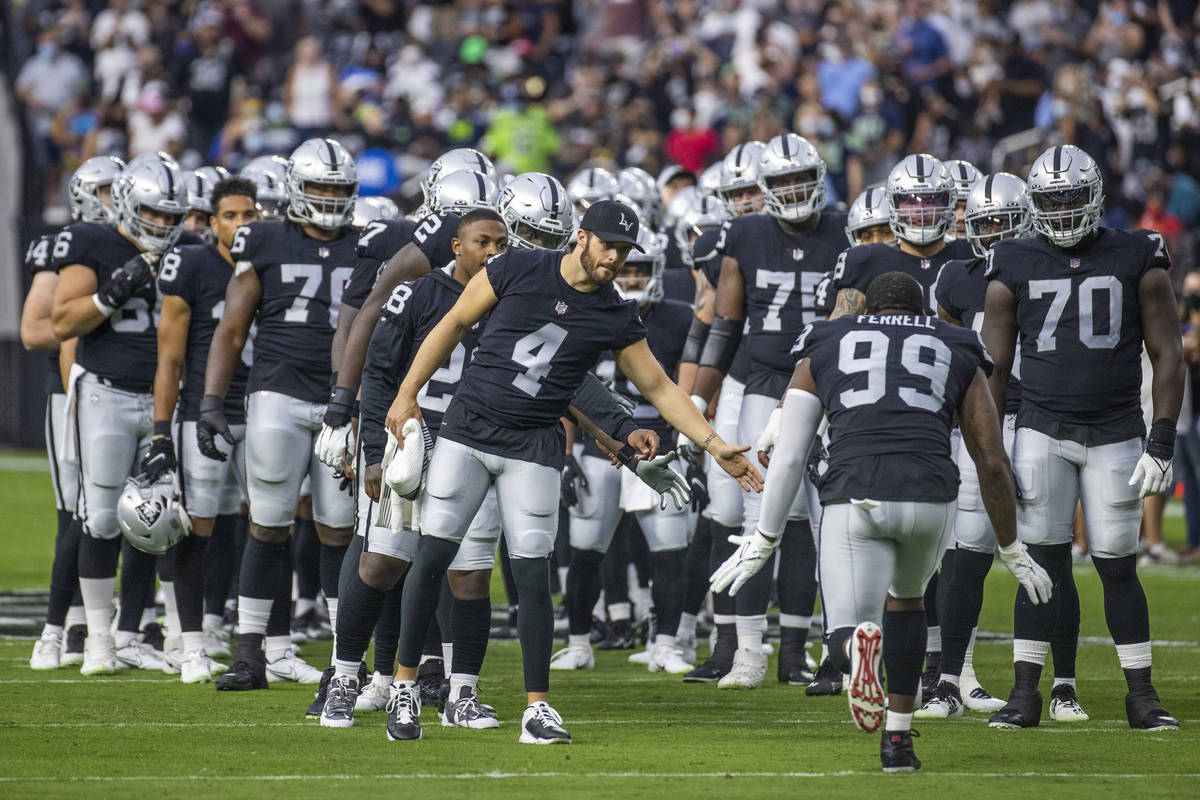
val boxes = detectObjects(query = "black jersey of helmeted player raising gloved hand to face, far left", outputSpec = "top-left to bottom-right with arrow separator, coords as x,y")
50,222 -> 158,392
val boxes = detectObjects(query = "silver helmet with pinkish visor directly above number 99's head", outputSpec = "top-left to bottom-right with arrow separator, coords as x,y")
883,152 -> 956,247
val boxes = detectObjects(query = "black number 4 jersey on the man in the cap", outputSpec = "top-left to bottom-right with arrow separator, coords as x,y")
443,248 -> 648,444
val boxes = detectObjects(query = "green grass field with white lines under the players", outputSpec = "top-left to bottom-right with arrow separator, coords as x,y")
0,459 -> 1200,799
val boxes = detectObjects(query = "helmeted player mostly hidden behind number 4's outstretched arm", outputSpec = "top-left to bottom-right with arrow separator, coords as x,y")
550,229 -> 695,674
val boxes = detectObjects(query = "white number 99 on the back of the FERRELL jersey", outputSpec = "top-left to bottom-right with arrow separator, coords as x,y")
838,331 -> 950,414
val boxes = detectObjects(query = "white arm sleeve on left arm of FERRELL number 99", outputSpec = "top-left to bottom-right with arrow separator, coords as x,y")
758,389 -> 823,536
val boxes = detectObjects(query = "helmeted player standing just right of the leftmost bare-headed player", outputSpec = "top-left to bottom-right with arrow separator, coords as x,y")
204,139 -> 358,691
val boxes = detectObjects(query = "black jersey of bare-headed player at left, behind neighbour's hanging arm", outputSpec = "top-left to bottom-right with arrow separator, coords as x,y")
158,245 -> 250,422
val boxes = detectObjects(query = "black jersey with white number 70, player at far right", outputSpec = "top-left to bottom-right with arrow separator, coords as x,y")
986,228 -> 1171,445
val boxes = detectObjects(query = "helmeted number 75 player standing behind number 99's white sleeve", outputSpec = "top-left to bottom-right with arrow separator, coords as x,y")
695,133 -> 846,688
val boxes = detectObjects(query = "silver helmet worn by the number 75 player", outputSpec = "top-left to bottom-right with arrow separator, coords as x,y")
758,133 -> 826,222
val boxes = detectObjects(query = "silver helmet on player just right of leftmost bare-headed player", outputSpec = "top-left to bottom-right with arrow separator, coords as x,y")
287,138 -> 359,230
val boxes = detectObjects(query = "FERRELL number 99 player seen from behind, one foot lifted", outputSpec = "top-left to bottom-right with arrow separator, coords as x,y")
713,272 -> 1050,772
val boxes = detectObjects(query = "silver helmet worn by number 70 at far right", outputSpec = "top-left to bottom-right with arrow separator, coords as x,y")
1025,144 -> 1104,247
